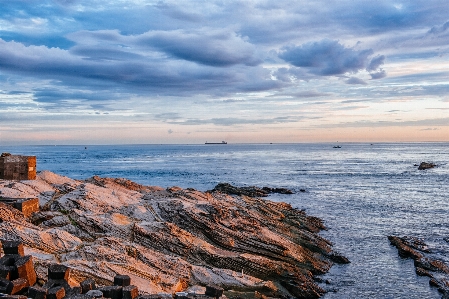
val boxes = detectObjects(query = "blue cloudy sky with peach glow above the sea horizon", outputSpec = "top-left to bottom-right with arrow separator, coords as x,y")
0,0 -> 449,145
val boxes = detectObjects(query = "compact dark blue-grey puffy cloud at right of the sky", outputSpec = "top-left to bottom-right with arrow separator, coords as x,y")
279,39 -> 373,76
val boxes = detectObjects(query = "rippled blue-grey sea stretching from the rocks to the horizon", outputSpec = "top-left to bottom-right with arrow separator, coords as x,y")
0,143 -> 449,299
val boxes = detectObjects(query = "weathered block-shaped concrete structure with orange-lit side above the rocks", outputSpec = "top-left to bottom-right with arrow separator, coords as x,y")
0,153 -> 36,180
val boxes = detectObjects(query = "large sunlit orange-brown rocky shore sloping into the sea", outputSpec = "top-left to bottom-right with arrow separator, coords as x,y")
0,171 -> 349,298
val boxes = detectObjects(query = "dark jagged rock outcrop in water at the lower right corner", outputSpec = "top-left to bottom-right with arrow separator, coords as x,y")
388,236 -> 449,299
